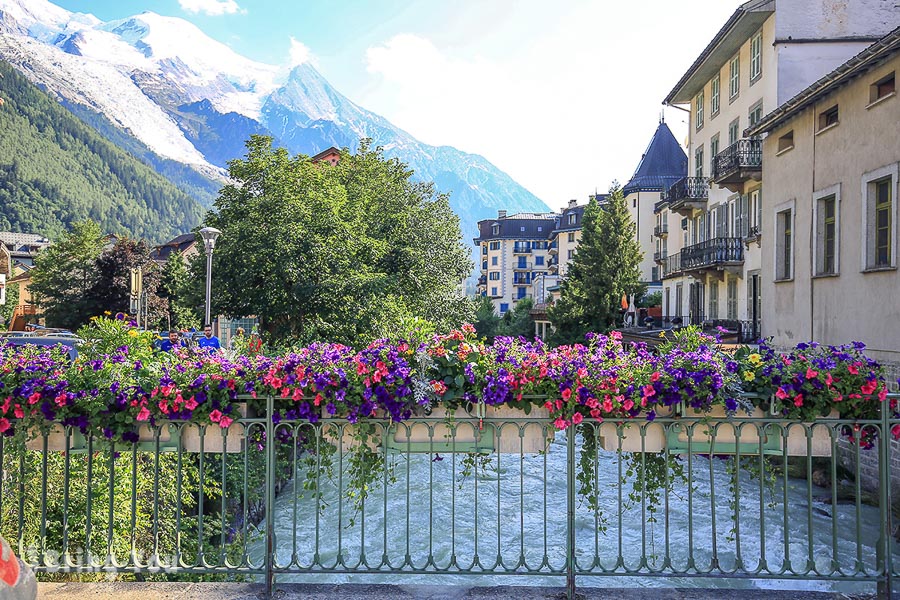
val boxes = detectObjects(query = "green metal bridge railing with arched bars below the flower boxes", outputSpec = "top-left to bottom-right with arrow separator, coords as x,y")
0,398 -> 900,598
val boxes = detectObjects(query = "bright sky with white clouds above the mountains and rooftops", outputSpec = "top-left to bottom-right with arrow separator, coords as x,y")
51,0 -> 738,208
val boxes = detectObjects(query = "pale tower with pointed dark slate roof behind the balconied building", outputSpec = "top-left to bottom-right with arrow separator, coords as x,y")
622,119 -> 687,293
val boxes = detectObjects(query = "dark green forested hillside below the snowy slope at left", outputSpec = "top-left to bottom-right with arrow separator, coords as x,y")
0,61 -> 204,241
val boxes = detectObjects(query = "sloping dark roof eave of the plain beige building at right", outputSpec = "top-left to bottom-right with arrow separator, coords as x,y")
744,27 -> 900,136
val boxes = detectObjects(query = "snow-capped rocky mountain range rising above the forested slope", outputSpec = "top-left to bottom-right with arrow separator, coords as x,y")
0,0 -> 547,237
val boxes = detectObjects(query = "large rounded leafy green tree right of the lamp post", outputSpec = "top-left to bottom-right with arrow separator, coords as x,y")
200,136 -> 471,343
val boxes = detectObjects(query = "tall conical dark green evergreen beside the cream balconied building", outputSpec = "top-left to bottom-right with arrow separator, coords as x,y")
548,184 -> 642,343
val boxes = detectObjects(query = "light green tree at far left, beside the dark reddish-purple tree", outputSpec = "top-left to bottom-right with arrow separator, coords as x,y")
30,220 -> 104,331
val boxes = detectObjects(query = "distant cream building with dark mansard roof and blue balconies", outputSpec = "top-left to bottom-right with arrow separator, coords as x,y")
475,210 -> 558,315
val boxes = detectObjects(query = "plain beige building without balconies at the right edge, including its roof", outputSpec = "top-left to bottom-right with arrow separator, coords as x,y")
747,28 -> 900,365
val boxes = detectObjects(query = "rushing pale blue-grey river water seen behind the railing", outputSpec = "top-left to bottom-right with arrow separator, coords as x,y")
251,435 -> 900,592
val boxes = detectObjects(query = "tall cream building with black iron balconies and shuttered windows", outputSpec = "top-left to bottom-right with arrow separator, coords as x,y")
655,0 -> 897,337
